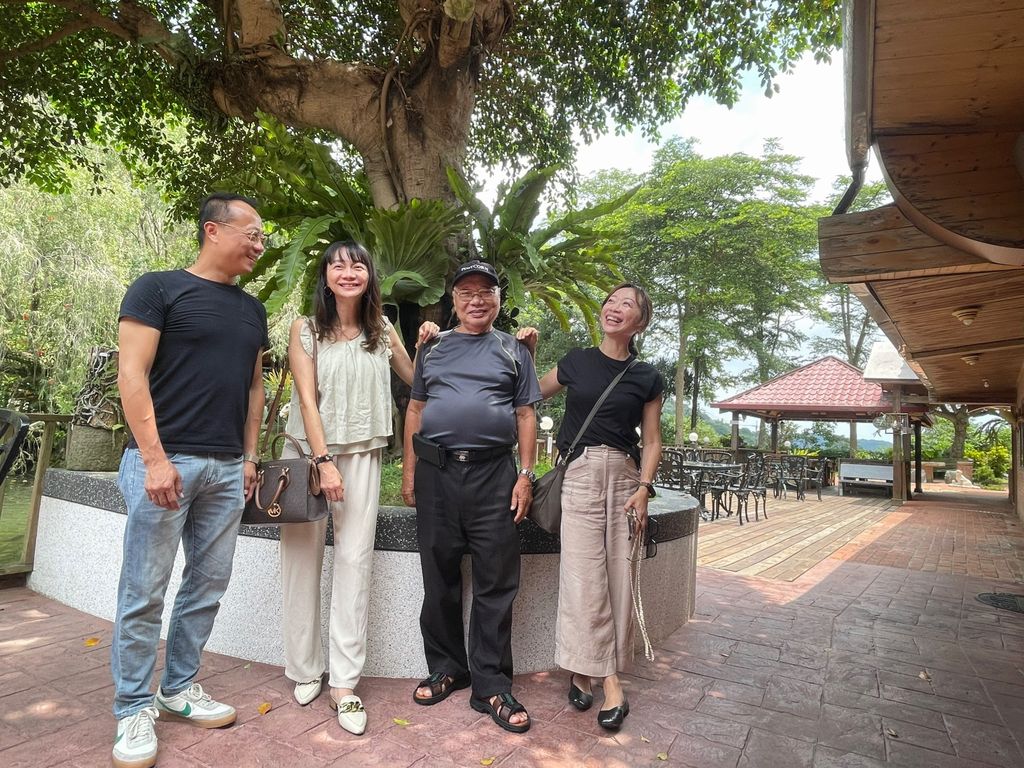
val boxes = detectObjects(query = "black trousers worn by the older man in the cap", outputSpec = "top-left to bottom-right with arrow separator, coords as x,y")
416,451 -> 519,697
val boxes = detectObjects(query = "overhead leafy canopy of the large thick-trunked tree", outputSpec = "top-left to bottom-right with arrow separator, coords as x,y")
0,0 -> 840,203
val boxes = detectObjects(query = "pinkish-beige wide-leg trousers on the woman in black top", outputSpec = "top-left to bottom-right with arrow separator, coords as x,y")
555,445 -> 640,677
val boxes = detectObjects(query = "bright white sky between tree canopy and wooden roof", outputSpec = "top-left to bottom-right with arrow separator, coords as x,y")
578,54 -> 887,439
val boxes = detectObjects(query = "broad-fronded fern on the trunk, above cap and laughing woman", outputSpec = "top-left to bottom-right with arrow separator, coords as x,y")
447,166 -> 637,340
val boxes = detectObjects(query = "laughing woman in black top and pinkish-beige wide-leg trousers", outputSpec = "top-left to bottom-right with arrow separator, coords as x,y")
519,284 -> 665,730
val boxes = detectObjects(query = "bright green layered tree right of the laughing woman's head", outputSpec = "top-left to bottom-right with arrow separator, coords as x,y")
584,139 -> 822,439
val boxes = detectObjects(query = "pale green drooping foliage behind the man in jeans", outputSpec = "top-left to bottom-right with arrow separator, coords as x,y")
0,150 -> 196,414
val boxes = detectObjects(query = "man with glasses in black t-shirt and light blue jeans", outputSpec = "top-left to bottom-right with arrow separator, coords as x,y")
111,195 -> 268,768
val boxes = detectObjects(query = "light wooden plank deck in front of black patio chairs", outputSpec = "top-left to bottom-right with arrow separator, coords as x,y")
697,488 -> 900,582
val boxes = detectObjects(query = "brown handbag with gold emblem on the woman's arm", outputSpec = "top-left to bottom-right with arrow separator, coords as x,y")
242,319 -> 329,525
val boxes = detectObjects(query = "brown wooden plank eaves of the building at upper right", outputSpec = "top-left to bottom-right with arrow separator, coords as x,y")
819,0 -> 1024,404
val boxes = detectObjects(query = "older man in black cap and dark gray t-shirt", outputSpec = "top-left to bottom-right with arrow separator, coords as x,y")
401,261 -> 541,733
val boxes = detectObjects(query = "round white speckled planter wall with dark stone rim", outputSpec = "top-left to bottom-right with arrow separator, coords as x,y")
29,469 -> 699,678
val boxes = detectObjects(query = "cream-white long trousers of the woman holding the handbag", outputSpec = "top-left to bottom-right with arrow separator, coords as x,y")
281,449 -> 381,688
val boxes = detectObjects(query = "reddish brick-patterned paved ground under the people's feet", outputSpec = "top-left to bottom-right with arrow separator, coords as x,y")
0,489 -> 1024,768
